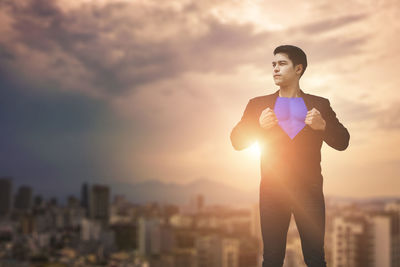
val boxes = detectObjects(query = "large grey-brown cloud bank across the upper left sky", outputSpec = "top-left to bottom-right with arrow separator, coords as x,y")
2,0 -> 268,94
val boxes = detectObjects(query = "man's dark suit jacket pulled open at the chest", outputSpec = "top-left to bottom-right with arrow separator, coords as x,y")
230,90 -> 350,184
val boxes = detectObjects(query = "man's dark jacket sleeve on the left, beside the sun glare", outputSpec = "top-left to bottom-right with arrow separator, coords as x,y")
230,100 -> 261,150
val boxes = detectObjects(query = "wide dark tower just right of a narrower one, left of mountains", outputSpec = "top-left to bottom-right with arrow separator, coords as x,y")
89,185 -> 110,226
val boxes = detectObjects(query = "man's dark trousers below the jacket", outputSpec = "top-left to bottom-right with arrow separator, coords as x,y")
260,177 -> 326,267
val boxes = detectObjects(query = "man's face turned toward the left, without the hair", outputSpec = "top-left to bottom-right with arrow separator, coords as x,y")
272,53 -> 301,86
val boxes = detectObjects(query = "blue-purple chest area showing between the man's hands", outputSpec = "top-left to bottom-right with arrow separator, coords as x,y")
274,97 -> 307,139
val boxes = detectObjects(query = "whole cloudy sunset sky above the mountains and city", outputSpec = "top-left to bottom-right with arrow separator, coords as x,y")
0,0 -> 400,197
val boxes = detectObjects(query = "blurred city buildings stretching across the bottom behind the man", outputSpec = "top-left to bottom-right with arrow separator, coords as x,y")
0,178 -> 400,267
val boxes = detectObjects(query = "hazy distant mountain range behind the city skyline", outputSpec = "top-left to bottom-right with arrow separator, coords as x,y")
0,176 -> 400,208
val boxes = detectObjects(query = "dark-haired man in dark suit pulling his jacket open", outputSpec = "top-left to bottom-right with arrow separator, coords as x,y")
230,45 -> 350,267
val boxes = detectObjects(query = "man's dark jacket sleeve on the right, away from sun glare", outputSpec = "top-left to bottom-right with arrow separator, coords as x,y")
322,99 -> 350,151
